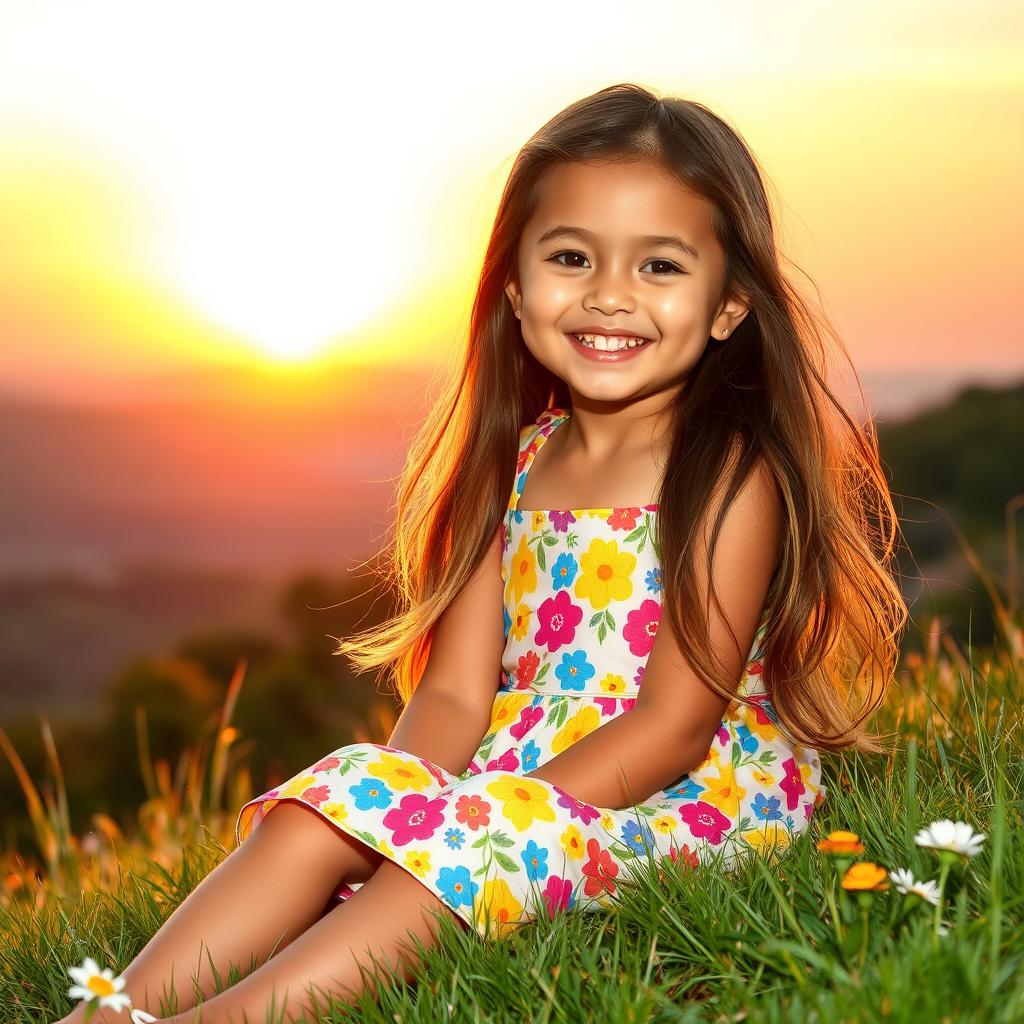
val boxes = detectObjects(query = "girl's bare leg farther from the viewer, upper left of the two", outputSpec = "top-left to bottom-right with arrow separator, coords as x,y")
52,801 -> 382,1024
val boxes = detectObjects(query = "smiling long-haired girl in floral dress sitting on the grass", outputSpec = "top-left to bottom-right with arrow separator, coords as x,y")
58,85 -> 906,1024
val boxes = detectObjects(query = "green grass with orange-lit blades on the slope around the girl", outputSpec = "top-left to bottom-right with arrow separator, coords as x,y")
0,591 -> 1024,1024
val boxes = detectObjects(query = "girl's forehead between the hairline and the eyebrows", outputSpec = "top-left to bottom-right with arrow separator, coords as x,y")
523,161 -> 715,251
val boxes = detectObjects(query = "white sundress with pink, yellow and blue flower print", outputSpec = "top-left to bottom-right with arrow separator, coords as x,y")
236,409 -> 825,938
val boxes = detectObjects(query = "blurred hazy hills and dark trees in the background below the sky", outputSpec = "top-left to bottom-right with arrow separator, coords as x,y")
0,376 -> 1024,846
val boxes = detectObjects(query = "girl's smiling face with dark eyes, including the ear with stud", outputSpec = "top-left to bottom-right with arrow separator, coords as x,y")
505,161 -> 748,401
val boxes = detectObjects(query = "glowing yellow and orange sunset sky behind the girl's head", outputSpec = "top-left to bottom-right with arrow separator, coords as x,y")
0,0 -> 1024,411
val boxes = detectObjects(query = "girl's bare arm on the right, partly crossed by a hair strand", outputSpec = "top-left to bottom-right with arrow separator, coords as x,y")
528,463 -> 781,809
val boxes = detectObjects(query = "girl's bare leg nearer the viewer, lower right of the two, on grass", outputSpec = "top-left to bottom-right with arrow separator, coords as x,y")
154,860 -> 469,1024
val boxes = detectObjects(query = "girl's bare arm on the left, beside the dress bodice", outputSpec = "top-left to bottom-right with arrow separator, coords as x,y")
388,530 -> 505,775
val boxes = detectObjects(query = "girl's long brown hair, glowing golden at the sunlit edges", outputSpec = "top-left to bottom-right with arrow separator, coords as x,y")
335,84 -> 908,752
